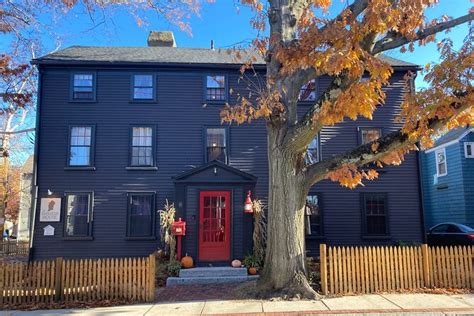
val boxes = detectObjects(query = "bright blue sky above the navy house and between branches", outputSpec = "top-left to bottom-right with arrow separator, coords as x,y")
29,0 -> 471,87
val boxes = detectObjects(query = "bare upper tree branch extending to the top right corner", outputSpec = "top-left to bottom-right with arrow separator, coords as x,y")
372,12 -> 474,55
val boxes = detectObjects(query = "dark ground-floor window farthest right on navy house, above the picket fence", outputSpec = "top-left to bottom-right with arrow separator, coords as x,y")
362,193 -> 388,237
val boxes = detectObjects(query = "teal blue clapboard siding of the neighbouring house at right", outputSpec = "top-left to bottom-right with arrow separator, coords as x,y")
421,132 -> 474,229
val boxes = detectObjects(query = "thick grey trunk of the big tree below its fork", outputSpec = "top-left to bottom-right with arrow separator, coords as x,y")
258,127 -> 317,298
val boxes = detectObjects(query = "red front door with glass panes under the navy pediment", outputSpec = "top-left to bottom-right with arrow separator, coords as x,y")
199,191 -> 231,261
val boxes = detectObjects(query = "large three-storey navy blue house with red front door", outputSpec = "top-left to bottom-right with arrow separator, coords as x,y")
32,32 -> 423,264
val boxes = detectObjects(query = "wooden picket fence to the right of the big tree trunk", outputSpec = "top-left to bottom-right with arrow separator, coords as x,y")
320,244 -> 474,294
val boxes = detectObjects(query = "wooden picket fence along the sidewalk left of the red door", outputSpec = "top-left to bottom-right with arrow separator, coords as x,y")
0,255 -> 156,306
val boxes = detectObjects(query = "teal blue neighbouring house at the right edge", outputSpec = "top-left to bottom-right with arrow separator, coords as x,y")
420,126 -> 474,229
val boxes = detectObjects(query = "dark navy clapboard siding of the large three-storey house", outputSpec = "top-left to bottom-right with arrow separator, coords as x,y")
34,67 -> 422,259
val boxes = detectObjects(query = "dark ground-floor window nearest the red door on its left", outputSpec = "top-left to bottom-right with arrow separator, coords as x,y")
127,193 -> 155,237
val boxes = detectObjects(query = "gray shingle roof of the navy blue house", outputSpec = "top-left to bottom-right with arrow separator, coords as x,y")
33,46 -> 418,67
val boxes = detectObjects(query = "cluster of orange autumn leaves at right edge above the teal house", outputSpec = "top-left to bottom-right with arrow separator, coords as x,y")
401,26 -> 474,148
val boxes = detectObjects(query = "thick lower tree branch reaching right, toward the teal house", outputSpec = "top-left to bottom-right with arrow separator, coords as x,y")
305,99 -> 472,187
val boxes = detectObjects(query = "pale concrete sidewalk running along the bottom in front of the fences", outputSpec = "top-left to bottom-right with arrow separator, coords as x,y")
0,294 -> 474,316
